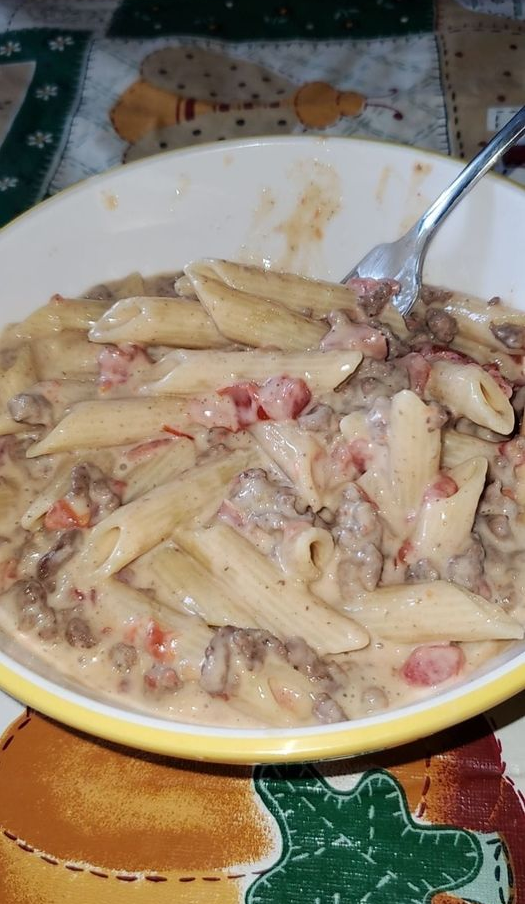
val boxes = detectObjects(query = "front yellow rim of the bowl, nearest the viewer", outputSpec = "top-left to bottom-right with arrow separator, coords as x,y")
0,663 -> 525,765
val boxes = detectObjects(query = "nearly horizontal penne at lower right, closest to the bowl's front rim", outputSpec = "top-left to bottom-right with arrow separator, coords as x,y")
347,581 -> 523,643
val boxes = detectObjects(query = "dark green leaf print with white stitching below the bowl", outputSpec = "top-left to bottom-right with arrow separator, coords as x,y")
246,766 -> 486,904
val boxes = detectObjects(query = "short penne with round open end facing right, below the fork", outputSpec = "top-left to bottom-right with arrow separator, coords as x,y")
425,361 -> 515,434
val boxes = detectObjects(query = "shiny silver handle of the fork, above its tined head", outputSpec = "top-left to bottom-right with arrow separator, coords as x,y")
410,107 -> 525,251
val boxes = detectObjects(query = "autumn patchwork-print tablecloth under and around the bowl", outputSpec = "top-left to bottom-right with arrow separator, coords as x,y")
0,0 -> 525,904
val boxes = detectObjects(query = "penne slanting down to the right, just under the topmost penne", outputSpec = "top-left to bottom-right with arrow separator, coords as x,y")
183,271 -> 328,351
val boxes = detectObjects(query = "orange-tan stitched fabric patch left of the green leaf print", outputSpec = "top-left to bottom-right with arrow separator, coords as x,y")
0,716 -> 273,875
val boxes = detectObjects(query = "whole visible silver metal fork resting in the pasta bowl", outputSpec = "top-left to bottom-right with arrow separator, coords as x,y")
341,107 -> 525,316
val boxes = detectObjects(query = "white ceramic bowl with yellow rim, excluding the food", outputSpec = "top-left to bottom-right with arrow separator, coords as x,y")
0,137 -> 525,763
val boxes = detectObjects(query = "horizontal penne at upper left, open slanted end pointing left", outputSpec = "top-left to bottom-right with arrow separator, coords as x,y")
88,296 -> 228,348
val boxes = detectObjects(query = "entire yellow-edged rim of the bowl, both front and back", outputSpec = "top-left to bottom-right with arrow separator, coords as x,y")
0,135 -> 525,765
